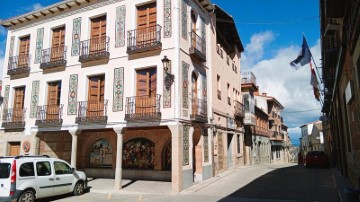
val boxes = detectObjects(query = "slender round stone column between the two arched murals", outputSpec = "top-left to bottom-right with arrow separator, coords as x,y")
114,128 -> 125,190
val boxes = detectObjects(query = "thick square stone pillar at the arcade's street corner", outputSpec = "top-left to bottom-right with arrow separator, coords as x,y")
168,125 -> 183,193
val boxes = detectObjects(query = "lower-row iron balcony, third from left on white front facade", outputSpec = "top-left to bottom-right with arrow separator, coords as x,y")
76,100 -> 108,124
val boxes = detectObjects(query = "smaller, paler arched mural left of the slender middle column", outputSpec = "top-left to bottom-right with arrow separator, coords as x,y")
90,139 -> 113,167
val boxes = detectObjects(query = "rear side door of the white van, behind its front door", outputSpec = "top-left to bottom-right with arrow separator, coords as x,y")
35,160 -> 55,198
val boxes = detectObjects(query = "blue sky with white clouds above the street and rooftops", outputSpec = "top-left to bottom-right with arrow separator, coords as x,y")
0,0 -> 321,145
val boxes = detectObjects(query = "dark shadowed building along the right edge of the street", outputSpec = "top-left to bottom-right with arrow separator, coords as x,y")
320,0 -> 360,189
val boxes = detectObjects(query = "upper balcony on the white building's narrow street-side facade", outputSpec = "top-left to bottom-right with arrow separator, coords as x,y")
189,31 -> 206,62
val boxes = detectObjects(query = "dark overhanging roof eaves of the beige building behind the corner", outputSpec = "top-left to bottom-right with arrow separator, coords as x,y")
215,5 -> 244,54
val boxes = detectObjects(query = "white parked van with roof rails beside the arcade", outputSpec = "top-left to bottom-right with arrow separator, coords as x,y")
0,156 -> 87,201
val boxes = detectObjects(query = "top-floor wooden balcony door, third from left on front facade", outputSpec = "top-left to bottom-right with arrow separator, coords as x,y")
90,15 -> 106,54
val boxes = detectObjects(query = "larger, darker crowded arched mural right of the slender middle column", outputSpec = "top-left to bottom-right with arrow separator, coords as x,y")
123,138 -> 155,170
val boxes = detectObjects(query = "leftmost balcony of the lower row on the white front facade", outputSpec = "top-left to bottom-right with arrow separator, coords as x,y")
1,108 -> 26,129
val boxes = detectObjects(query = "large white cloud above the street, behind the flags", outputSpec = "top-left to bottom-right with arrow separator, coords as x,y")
242,31 -> 321,145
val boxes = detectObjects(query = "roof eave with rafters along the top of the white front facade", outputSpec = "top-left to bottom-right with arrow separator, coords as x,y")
1,0 -> 94,28
